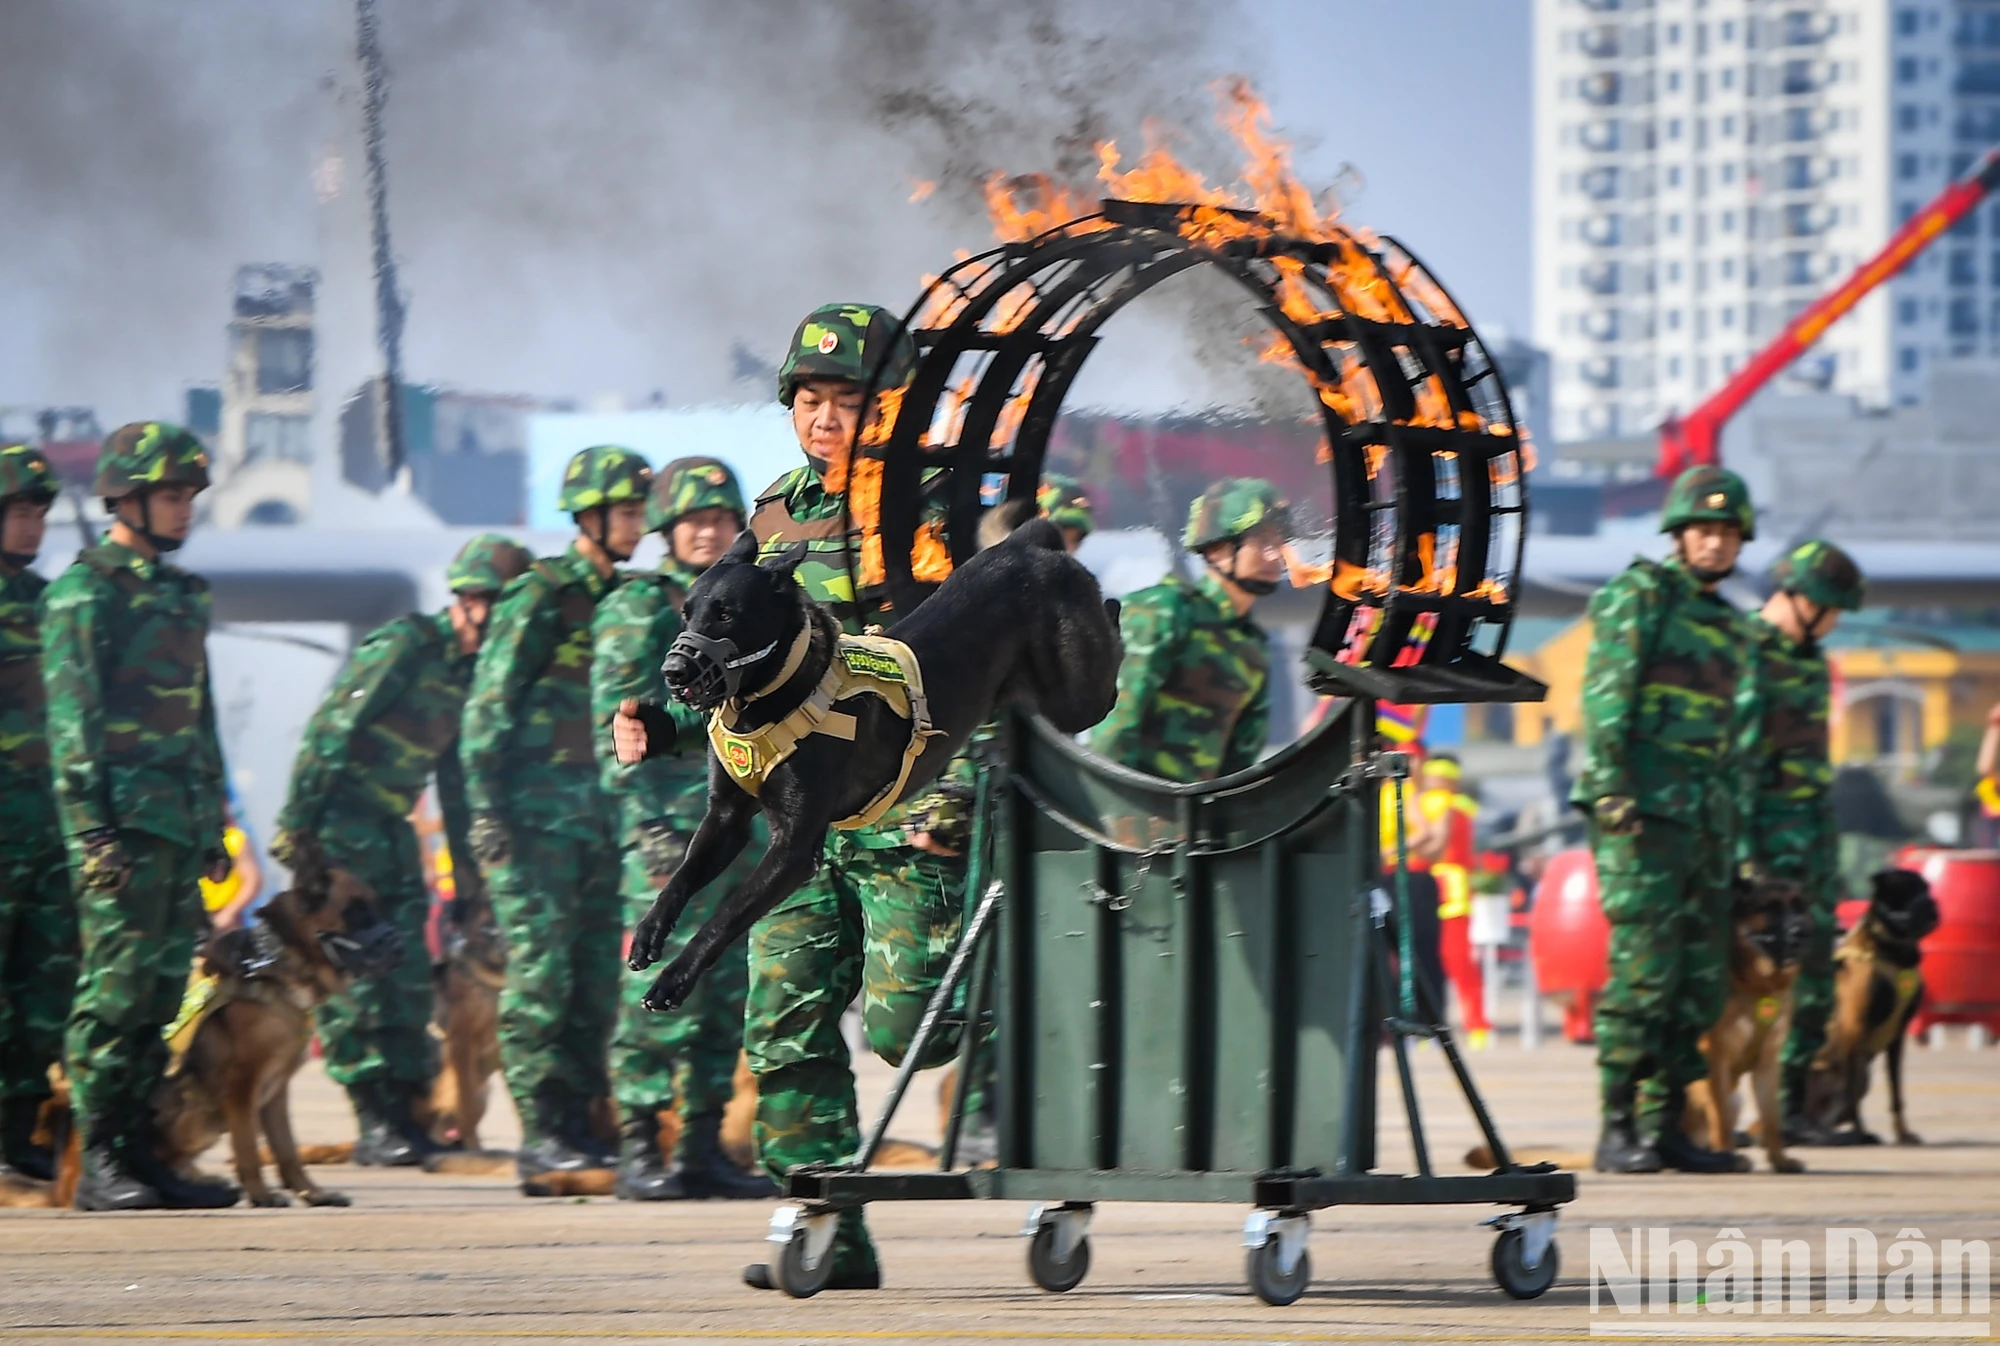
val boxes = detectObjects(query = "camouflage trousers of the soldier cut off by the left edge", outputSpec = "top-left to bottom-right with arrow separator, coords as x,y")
0,836 -> 76,1100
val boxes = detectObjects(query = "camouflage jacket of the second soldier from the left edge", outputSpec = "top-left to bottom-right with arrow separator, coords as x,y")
42,540 -> 222,846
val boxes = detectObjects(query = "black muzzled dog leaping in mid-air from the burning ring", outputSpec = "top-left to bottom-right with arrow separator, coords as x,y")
630,520 -> 1124,1010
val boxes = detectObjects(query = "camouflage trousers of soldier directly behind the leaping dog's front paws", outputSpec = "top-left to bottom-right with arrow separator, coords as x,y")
612,826 -> 762,1120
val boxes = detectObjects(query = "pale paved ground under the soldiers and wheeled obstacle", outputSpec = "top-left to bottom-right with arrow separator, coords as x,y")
0,1042 -> 2000,1342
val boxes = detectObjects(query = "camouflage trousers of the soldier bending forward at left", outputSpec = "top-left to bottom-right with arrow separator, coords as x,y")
318,810 -> 438,1090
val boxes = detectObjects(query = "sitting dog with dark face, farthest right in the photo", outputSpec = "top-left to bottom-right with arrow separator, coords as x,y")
1806,870 -> 1938,1146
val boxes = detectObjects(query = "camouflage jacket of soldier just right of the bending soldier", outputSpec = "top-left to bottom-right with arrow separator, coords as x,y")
458,548 -> 620,840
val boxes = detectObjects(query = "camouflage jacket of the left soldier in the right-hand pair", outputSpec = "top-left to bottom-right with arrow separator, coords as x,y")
1570,560 -> 1752,826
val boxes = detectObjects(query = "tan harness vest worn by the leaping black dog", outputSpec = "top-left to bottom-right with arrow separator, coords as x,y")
708,622 -> 942,832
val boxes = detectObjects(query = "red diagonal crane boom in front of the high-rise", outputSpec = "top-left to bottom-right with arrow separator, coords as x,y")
1654,148 -> 2000,478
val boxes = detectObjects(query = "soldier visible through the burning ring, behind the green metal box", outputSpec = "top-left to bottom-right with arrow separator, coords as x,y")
1090,476 -> 1288,782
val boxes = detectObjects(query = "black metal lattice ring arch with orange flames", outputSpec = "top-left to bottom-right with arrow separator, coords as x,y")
864,200 -> 1542,702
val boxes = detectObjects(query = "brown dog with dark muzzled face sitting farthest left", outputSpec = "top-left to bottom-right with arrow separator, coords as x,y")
154,868 -> 402,1206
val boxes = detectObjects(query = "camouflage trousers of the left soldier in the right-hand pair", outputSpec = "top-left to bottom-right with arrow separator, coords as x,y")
1590,818 -> 1730,1132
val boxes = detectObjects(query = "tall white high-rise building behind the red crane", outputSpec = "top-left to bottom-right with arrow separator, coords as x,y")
1534,0 -> 2000,440
